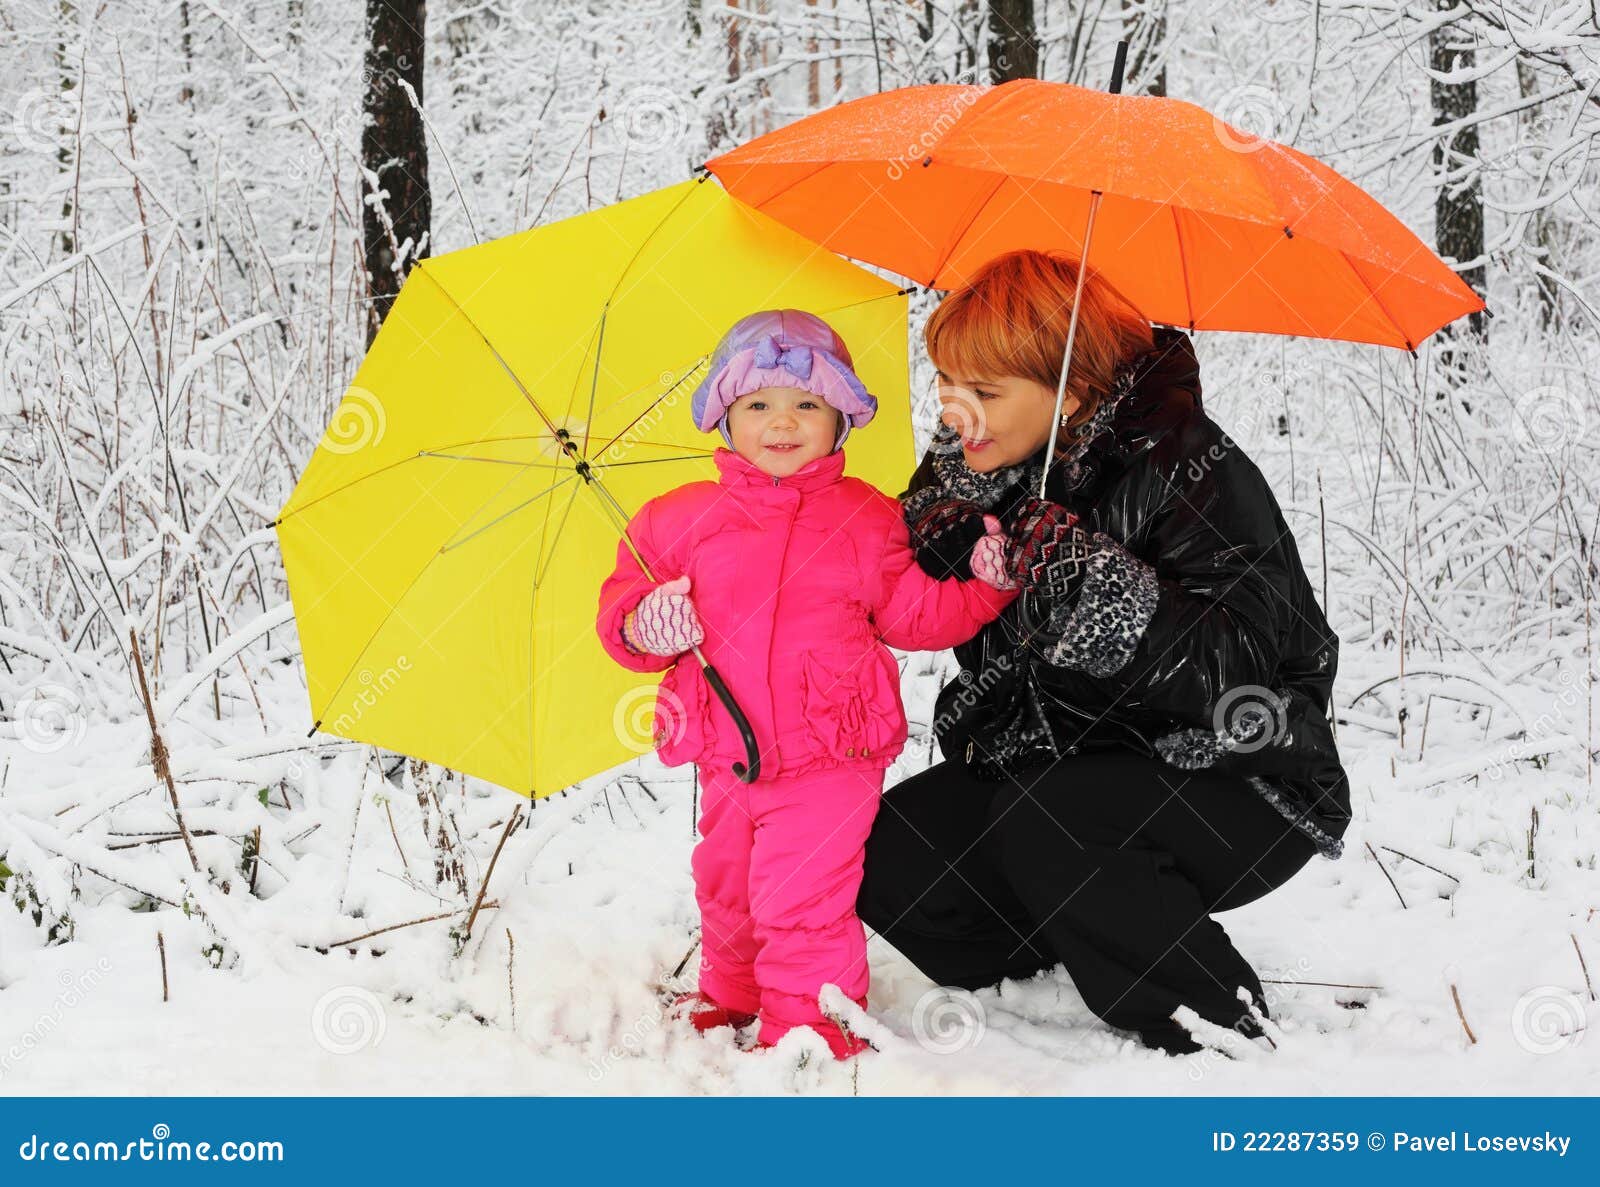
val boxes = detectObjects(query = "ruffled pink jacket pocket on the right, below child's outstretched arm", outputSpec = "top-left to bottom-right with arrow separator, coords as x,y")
800,646 -> 906,758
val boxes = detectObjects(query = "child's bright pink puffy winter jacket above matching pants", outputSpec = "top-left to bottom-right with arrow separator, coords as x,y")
597,448 -> 1016,779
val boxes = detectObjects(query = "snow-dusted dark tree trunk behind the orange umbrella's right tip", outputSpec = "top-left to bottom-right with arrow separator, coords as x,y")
1429,0 -> 1486,374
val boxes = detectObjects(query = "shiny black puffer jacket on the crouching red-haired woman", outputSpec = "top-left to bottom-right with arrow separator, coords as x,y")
901,326 -> 1350,857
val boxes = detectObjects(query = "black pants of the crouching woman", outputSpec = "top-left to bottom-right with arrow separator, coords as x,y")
856,749 -> 1315,1053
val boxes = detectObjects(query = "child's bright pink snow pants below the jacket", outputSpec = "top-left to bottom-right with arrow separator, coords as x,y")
690,763 -> 883,1054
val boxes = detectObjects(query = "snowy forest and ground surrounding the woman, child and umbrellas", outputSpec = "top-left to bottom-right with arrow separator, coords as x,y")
0,0 -> 1600,1094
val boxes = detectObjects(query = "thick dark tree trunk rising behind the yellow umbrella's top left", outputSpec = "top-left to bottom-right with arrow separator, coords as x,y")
362,0 -> 434,346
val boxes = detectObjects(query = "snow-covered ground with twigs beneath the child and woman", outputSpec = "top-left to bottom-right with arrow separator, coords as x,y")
0,633 -> 1600,1094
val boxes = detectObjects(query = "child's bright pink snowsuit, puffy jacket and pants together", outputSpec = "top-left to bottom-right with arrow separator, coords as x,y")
597,448 -> 1016,1053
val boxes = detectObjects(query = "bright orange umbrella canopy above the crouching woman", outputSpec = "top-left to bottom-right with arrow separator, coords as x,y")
706,78 -> 1483,349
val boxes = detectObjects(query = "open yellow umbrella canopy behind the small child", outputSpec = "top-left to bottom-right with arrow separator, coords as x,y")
275,178 -> 915,797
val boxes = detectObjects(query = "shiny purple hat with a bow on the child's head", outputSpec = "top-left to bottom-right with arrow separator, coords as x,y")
690,309 -> 878,450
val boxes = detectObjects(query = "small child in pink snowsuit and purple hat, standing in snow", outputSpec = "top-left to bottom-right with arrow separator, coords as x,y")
597,309 -> 1016,1059
